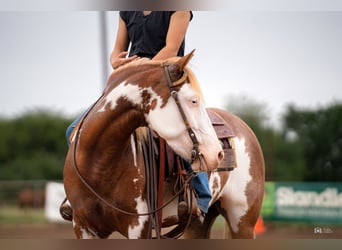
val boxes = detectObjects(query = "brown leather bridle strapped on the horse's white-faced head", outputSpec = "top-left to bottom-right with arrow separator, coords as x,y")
163,64 -> 202,167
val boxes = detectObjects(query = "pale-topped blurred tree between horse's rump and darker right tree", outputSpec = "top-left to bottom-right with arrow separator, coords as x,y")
226,96 -> 306,181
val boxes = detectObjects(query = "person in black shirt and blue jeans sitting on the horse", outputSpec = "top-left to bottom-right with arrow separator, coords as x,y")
61,11 -> 211,221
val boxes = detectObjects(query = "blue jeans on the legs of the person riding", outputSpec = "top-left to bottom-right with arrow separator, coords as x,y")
66,111 -> 211,213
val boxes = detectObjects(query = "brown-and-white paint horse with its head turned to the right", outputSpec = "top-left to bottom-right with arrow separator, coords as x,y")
63,52 -> 264,239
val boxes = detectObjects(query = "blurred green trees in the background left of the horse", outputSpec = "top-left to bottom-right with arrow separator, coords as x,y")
0,110 -> 71,180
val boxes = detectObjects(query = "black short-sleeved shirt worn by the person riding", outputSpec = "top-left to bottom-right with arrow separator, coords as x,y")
120,11 -> 192,58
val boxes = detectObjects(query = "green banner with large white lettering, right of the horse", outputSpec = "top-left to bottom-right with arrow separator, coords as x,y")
261,182 -> 342,223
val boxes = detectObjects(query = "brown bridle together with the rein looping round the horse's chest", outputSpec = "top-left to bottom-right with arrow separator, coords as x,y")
72,64 -> 202,216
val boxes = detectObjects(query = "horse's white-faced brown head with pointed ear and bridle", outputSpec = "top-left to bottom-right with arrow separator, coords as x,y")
145,52 -> 224,171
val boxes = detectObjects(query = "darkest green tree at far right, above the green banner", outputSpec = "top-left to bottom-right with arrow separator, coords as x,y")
284,103 -> 342,181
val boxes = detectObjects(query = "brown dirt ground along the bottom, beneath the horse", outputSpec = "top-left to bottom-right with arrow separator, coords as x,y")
0,222 -> 342,239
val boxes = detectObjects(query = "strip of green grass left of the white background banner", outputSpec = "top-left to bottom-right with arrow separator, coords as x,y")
0,207 -> 47,225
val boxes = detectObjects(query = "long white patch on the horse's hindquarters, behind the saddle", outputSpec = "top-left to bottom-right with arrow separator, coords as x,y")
222,138 -> 252,232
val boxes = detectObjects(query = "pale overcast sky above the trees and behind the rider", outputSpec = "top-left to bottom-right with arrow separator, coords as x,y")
0,10 -> 342,127
